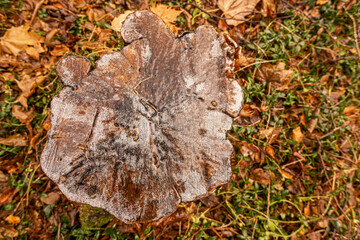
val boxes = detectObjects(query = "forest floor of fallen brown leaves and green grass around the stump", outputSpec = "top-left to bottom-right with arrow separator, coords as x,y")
0,0 -> 360,240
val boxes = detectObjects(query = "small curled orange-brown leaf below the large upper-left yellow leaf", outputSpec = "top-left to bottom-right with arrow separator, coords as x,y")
15,75 -> 46,108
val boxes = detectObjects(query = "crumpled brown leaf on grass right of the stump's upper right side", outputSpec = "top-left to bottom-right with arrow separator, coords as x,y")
256,62 -> 294,91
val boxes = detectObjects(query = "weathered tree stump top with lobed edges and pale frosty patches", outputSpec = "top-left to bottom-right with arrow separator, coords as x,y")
41,11 -> 243,222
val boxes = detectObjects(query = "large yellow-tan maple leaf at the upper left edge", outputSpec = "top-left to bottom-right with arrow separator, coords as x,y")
0,25 -> 44,56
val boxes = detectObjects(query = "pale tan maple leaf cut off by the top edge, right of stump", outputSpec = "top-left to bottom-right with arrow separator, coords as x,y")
218,0 -> 260,26
